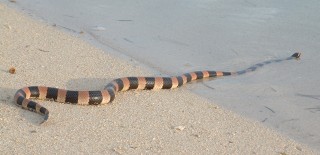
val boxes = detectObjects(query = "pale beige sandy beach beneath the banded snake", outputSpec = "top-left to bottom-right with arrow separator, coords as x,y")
0,4 -> 318,154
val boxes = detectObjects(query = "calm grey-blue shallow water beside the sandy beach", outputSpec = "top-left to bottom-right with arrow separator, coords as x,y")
0,0 -> 320,150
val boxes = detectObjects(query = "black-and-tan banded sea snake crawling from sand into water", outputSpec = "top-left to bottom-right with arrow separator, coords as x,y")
14,53 -> 301,123
